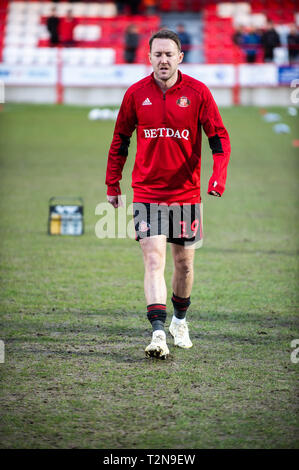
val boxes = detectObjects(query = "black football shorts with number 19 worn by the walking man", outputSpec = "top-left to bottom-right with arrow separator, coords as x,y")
133,202 -> 203,247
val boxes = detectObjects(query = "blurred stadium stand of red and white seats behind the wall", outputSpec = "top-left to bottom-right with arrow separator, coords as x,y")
0,0 -> 299,65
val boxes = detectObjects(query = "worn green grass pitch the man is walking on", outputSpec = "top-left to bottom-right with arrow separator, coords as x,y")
0,105 -> 299,449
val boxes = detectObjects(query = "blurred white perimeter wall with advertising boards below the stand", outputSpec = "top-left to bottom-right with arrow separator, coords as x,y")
0,64 -> 299,106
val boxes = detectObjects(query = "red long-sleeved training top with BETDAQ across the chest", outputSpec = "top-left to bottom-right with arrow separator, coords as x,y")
106,71 -> 230,204
